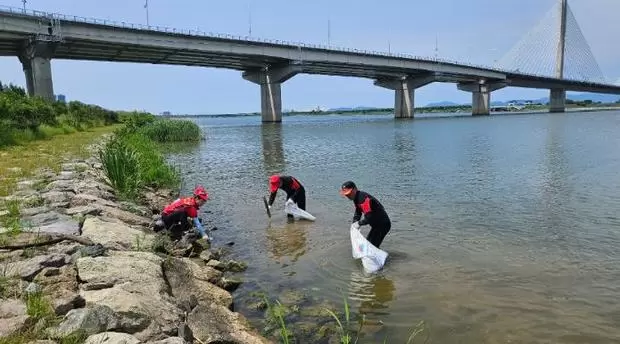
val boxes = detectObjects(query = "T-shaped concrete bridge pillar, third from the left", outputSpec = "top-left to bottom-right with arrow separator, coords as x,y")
374,75 -> 435,118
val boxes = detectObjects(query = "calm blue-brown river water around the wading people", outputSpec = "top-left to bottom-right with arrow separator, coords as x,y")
171,111 -> 620,343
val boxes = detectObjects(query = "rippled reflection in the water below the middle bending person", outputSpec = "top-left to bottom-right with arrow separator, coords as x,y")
266,222 -> 308,264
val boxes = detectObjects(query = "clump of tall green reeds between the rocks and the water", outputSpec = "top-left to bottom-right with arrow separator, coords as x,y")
99,113 -> 202,200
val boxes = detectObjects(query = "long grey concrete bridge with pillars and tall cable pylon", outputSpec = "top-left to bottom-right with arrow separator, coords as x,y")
0,0 -> 620,122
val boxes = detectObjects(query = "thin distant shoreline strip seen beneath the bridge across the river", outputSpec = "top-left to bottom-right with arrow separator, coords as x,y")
161,103 -> 620,118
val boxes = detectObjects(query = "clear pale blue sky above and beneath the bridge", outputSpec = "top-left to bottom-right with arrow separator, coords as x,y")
0,0 -> 620,114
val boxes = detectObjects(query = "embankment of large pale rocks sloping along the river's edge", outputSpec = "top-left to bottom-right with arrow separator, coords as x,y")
0,144 -> 270,344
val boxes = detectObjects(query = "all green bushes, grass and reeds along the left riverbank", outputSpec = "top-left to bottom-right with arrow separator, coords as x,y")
0,84 -> 202,199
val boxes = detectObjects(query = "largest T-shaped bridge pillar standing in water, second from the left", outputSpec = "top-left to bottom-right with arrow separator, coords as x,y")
242,65 -> 301,123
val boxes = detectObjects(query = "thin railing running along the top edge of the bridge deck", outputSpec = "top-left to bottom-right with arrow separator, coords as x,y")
0,5 -> 613,85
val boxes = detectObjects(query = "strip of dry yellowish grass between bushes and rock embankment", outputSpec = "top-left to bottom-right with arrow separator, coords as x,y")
0,125 -> 121,196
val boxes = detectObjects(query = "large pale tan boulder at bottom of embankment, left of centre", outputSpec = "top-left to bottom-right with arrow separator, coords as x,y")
77,251 -> 182,340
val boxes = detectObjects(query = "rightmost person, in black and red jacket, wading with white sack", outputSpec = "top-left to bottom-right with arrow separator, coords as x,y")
340,181 -> 392,248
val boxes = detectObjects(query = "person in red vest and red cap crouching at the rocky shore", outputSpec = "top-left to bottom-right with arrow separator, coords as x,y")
155,186 -> 210,241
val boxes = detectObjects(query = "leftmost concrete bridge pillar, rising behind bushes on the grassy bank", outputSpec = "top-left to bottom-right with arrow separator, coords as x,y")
19,40 -> 56,101
